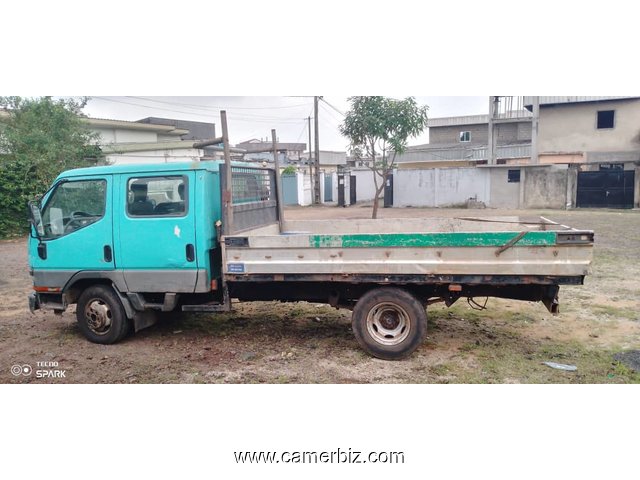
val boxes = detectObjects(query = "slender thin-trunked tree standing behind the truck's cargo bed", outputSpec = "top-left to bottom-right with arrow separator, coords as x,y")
340,97 -> 429,218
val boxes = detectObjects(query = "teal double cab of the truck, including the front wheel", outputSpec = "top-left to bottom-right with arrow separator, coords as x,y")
29,162 -> 235,343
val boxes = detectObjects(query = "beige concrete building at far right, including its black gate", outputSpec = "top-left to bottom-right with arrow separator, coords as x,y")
525,96 -> 640,208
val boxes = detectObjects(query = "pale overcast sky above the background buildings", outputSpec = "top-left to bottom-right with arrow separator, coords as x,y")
84,96 -> 489,151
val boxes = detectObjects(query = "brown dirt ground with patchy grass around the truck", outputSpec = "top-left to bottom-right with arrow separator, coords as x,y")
0,207 -> 640,383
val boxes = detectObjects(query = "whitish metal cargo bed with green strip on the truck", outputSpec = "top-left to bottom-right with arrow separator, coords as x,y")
222,217 -> 593,284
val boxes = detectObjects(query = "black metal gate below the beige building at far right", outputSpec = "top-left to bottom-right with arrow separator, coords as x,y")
576,170 -> 635,208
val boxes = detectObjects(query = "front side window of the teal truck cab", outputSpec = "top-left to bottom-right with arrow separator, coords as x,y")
42,180 -> 107,239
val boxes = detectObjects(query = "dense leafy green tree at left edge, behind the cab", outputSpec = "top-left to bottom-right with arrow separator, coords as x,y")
0,97 -> 100,237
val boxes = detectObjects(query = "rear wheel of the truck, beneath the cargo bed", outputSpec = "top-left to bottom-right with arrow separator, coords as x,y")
351,287 -> 427,360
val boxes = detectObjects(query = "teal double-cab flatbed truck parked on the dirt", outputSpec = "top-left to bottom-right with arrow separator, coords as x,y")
29,161 -> 594,359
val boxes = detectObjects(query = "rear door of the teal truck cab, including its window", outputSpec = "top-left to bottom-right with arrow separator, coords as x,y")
115,171 -> 198,293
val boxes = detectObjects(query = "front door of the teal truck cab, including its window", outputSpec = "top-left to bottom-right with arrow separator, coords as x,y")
29,175 -> 115,291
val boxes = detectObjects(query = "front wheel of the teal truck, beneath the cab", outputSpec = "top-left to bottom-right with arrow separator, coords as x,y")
76,285 -> 129,345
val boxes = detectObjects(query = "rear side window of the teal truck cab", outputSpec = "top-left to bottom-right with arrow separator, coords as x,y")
127,176 -> 188,217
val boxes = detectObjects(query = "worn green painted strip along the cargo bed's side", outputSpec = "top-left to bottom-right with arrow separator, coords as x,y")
309,232 -> 556,248
